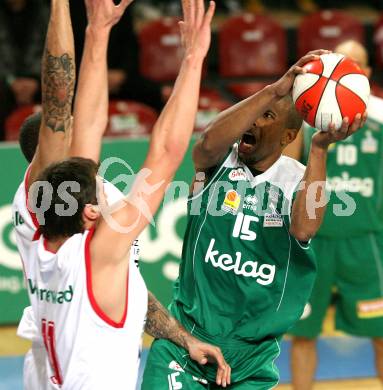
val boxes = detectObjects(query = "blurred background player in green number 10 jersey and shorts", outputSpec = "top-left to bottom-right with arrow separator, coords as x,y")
285,41 -> 383,390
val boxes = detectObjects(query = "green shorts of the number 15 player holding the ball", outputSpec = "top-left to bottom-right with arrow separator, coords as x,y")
141,339 -> 279,390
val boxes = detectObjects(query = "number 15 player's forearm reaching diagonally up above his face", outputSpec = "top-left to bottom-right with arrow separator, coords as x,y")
196,85 -> 279,165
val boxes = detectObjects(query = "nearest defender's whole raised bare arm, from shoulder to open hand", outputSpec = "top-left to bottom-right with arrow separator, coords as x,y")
92,0 -> 215,261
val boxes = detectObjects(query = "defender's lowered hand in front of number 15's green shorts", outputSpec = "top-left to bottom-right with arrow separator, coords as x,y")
187,336 -> 231,387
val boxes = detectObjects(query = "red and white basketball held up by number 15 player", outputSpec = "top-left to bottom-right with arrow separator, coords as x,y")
293,53 -> 370,131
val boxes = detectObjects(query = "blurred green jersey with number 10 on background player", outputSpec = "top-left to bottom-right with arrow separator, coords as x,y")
304,96 -> 383,238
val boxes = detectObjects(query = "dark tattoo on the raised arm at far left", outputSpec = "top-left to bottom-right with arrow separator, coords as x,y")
42,49 -> 75,132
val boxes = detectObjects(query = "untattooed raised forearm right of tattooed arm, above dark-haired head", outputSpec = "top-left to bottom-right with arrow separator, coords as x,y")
71,26 -> 110,161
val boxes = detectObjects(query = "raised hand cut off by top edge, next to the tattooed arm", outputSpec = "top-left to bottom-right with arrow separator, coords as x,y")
85,0 -> 133,29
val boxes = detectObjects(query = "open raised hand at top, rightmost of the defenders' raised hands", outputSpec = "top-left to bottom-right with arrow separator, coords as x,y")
179,0 -> 215,58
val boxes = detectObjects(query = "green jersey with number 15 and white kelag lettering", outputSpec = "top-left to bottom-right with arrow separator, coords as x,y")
172,145 -> 316,345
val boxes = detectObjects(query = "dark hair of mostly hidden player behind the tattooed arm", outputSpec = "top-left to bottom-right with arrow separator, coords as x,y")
19,112 -> 42,162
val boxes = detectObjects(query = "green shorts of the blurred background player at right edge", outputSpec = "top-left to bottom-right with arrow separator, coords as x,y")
289,233 -> 383,338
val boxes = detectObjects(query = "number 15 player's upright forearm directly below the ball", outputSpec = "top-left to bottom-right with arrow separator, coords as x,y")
290,145 -> 327,242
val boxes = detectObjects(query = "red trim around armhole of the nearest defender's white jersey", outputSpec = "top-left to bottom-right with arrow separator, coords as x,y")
85,229 -> 129,328
